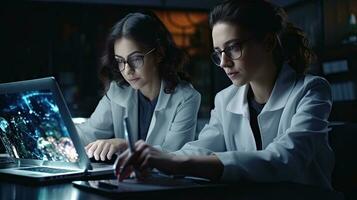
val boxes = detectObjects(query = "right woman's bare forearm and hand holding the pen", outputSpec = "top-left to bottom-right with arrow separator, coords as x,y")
115,140 -> 224,181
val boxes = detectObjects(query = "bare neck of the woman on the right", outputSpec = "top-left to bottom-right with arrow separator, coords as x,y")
250,64 -> 278,104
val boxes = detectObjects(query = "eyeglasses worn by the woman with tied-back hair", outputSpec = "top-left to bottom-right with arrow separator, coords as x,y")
211,39 -> 250,67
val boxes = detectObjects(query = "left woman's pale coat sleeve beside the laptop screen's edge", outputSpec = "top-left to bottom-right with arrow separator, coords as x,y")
76,95 -> 114,145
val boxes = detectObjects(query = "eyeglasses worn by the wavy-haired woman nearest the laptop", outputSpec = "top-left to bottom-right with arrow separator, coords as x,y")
115,48 -> 155,72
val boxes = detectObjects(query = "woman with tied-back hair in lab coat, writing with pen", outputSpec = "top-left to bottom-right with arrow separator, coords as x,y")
117,0 -> 334,188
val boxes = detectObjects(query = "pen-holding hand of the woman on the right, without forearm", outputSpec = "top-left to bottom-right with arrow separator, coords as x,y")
115,140 -> 177,181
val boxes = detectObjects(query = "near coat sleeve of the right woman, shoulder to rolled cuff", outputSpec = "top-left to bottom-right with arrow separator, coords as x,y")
211,79 -> 332,181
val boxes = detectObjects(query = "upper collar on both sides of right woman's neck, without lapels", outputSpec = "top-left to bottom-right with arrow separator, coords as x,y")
226,64 -> 296,118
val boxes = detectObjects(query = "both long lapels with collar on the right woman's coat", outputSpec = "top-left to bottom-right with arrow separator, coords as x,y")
226,65 -> 296,151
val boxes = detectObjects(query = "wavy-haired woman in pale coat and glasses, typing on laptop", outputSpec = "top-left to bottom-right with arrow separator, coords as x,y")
77,12 -> 201,161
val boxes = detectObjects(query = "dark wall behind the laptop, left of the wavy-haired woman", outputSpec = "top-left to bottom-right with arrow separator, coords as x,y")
0,2 -> 136,116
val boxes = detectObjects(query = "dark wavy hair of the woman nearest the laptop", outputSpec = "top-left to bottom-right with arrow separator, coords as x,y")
99,11 -> 190,93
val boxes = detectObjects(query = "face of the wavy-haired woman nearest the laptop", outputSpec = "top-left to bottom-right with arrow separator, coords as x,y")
114,37 -> 159,90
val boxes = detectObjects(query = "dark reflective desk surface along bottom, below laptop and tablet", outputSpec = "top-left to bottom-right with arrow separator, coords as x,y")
0,180 -> 343,200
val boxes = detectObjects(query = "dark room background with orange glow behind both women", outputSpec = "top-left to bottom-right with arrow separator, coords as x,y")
0,0 -> 357,122
